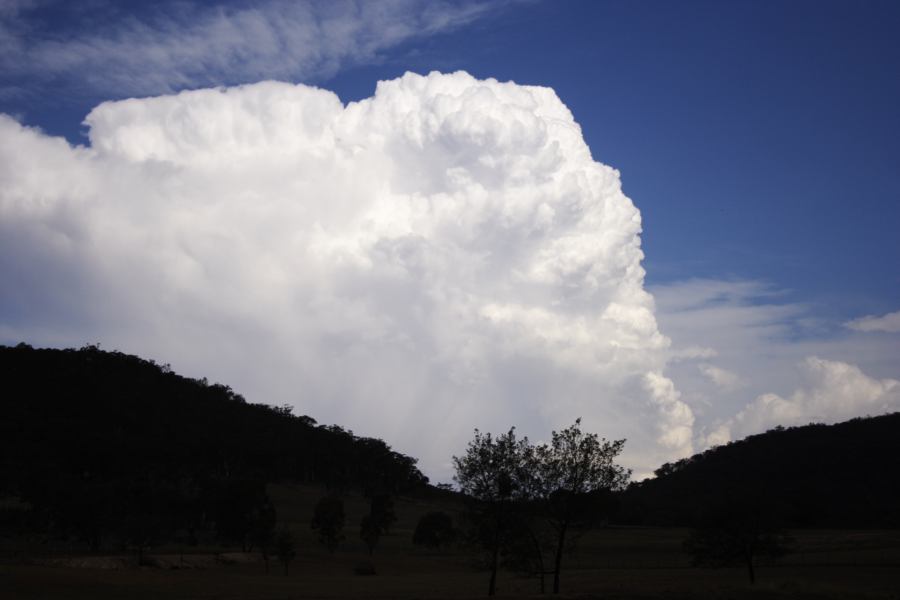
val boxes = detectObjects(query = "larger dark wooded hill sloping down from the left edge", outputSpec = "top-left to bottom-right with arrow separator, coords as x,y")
0,344 -> 427,547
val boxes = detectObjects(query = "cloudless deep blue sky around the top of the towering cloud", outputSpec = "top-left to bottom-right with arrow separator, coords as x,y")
0,1 -> 900,321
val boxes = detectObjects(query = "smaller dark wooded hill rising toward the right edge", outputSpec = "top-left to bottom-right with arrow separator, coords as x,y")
621,413 -> 900,527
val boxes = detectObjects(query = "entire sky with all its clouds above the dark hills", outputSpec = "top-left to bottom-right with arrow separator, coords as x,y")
0,0 -> 900,480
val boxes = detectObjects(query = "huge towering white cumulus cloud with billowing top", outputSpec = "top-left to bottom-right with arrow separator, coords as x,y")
0,73 -> 694,478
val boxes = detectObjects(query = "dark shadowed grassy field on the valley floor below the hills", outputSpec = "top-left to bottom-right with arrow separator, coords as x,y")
0,486 -> 900,600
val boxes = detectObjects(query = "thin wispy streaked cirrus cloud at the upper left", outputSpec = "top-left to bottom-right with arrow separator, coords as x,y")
0,0 -> 506,98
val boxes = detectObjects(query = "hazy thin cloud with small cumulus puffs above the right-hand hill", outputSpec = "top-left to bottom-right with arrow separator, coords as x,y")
652,279 -> 900,449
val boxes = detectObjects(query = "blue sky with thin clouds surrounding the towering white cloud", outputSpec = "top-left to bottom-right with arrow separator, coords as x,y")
0,0 -> 900,472
